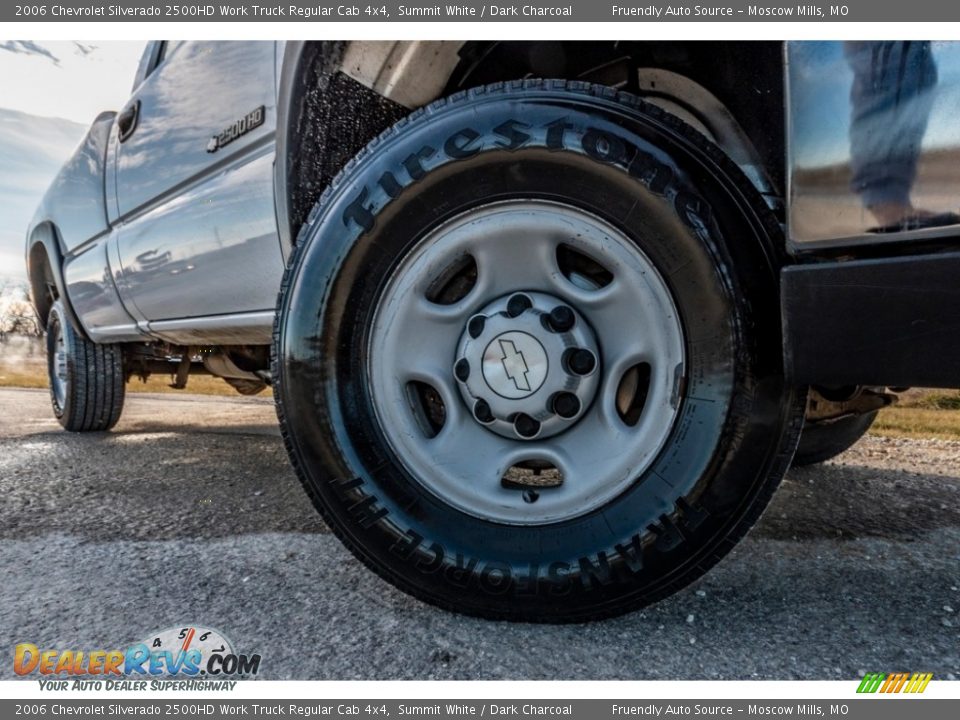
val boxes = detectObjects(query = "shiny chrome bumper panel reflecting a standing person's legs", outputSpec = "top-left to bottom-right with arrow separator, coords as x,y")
786,41 -> 960,246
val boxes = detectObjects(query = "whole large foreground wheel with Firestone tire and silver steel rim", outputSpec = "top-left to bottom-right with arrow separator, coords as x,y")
273,81 -> 804,622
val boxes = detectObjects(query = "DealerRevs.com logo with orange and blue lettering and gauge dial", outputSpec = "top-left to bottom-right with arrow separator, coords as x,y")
13,625 -> 260,689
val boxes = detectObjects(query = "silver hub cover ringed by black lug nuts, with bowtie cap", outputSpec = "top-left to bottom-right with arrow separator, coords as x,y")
454,292 -> 600,440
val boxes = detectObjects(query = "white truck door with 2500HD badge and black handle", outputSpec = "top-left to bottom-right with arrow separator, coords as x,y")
107,42 -> 283,325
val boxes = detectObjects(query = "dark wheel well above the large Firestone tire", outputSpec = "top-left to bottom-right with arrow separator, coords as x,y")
277,41 -> 785,244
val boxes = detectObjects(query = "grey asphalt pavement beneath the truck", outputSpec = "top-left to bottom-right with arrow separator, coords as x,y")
0,389 -> 960,680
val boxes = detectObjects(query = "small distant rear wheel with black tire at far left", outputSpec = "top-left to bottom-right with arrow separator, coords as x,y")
47,301 -> 126,432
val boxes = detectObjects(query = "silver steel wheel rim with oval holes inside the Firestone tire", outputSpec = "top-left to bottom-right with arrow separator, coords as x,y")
367,200 -> 684,525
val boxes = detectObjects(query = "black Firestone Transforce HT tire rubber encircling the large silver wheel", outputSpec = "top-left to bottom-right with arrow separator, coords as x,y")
273,81 -> 804,622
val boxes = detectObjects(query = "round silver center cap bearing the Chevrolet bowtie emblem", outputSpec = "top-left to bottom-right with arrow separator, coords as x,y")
482,330 -> 550,400
